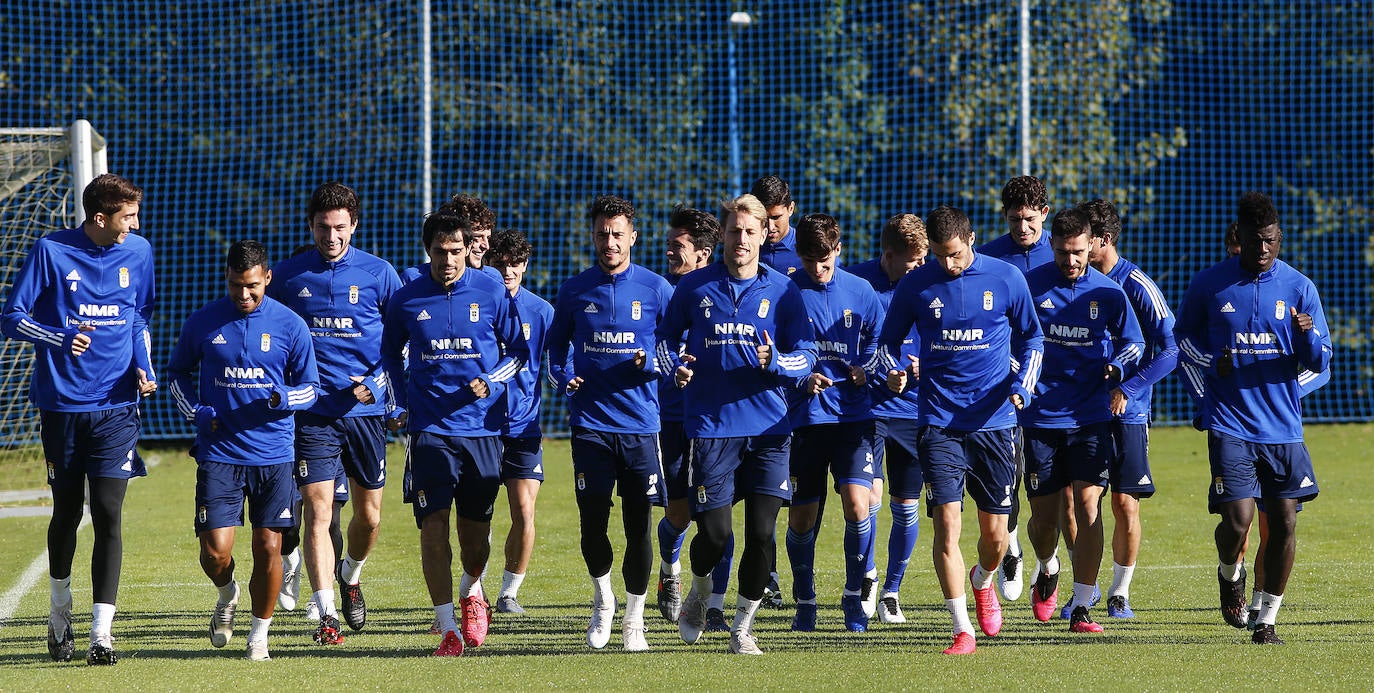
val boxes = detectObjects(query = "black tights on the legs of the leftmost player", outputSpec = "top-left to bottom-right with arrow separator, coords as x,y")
48,479 -> 129,604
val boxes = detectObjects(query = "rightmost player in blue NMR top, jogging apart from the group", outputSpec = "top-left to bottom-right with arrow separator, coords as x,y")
1178,193 -> 1331,645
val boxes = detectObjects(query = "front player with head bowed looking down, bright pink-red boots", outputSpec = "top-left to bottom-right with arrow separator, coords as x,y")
878,206 -> 1043,655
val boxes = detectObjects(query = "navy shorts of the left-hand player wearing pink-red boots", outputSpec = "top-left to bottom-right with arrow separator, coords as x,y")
411,430 -> 502,527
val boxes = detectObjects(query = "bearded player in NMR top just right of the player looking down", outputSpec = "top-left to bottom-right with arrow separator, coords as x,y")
1018,208 -> 1145,633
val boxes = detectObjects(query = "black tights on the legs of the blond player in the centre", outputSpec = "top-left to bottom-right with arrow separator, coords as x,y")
691,494 -> 782,600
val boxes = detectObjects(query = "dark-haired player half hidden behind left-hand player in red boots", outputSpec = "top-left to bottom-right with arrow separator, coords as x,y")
486,228 -> 554,613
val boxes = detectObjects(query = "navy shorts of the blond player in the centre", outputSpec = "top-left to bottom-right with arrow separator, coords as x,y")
691,435 -> 791,513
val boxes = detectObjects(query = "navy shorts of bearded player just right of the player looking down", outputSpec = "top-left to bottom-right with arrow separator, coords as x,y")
1021,421 -> 1112,498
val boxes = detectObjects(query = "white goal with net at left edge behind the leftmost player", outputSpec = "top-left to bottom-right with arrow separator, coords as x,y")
0,121 -> 106,490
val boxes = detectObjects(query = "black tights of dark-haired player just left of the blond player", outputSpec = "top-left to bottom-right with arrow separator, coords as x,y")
577,496 -> 654,594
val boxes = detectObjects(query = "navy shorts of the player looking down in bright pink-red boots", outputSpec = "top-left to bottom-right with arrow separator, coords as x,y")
919,426 -> 1015,517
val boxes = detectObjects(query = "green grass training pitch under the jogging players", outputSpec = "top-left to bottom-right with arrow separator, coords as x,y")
0,425 -> 1374,690
